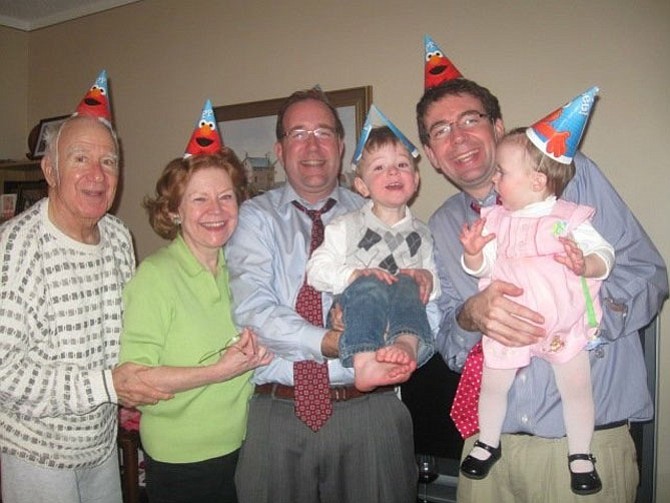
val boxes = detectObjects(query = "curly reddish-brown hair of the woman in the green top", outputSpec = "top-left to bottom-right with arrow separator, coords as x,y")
142,146 -> 247,239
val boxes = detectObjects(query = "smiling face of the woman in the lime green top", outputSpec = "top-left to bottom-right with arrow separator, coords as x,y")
178,167 -> 238,269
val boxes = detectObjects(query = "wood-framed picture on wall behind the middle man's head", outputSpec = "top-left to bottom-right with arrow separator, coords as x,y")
214,86 -> 372,195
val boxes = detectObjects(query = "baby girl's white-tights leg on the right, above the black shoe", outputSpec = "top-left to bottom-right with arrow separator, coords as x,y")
553,351 -> 595,473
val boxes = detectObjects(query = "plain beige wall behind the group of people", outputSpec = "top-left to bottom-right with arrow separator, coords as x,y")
0,0 -> 670,501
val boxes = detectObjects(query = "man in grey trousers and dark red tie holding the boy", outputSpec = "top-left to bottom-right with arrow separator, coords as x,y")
226,89 -> 417,503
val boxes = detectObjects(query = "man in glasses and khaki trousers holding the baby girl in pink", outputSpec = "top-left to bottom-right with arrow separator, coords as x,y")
416,79 -> 668,503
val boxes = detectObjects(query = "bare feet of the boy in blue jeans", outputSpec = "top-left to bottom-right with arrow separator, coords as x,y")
353,334 -> 419,391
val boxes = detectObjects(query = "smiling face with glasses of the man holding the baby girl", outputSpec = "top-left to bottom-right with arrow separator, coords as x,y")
423,93 -> 504,199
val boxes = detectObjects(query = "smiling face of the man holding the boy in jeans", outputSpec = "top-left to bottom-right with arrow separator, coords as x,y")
275,99 -> 344,203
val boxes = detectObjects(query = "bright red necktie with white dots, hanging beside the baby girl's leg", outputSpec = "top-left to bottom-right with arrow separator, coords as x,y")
449,341 -> 484,438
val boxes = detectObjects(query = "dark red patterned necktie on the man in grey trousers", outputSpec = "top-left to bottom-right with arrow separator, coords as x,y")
293,198 -> 336,431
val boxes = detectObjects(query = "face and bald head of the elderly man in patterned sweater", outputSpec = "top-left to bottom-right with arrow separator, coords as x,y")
42,117 -> 119,240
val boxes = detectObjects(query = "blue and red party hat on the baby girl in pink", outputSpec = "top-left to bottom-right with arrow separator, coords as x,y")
526,86 -> 599,164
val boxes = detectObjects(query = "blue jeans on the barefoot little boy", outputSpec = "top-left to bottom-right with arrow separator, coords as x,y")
340,274 -> 434,367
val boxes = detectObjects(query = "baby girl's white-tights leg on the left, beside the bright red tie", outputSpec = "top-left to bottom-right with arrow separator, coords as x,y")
470,363 -> 517,460
